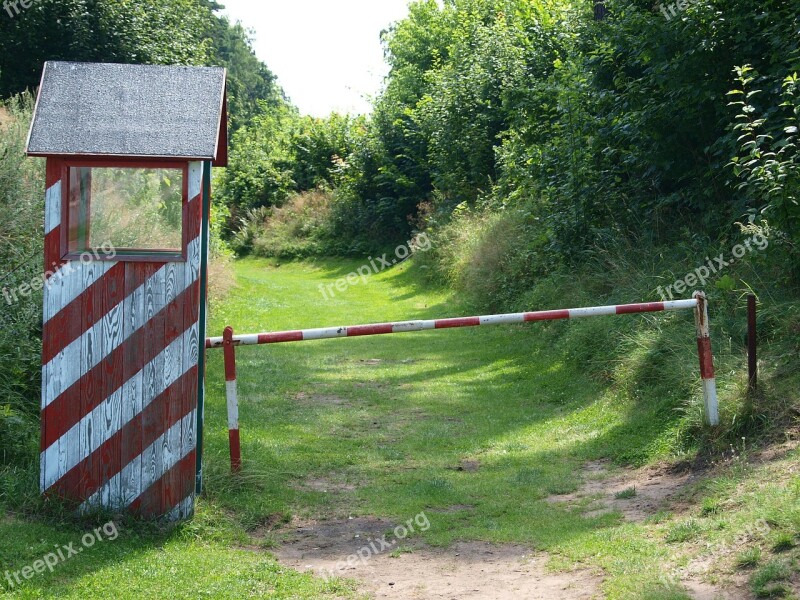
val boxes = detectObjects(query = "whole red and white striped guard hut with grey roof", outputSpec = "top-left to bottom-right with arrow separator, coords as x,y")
27,62 -> 227,520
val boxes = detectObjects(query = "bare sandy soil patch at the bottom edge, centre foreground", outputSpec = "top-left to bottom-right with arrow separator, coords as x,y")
275,518 -> 602,600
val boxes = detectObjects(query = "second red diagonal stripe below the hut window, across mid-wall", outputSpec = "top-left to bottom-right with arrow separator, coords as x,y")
42,285 -> 199,448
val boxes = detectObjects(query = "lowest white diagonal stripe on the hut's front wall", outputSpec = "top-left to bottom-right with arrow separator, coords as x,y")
80,410 -> 197,512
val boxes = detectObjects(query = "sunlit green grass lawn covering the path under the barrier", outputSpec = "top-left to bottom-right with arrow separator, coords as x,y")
0,260 -> 800,599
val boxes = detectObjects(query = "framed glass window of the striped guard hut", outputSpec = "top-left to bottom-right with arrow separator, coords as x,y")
66,164 -> 186,259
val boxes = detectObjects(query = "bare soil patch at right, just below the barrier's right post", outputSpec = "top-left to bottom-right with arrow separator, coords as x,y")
547,461 -> 700,522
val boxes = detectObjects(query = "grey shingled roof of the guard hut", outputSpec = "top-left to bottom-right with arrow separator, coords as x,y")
28,62 -> 228,166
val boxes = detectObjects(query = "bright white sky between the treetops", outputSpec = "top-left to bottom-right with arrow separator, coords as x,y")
223,0 -> 416,117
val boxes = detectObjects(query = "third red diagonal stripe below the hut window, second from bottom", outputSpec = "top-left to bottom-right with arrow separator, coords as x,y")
48,366 -> 197,502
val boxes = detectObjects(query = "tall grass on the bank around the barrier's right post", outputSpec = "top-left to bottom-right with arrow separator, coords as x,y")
418,203 -> 800,463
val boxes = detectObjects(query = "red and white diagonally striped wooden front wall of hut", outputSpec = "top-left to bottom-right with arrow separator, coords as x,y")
40,158 -> 204,519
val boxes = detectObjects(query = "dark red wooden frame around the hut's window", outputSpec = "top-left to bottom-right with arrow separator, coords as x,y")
61,158 -> 191,263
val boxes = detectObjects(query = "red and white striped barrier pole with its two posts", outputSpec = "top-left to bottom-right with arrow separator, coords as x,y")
206,292 -> 719,472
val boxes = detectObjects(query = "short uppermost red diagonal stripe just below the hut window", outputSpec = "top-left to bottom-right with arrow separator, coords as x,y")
42,263 -> 125,364
